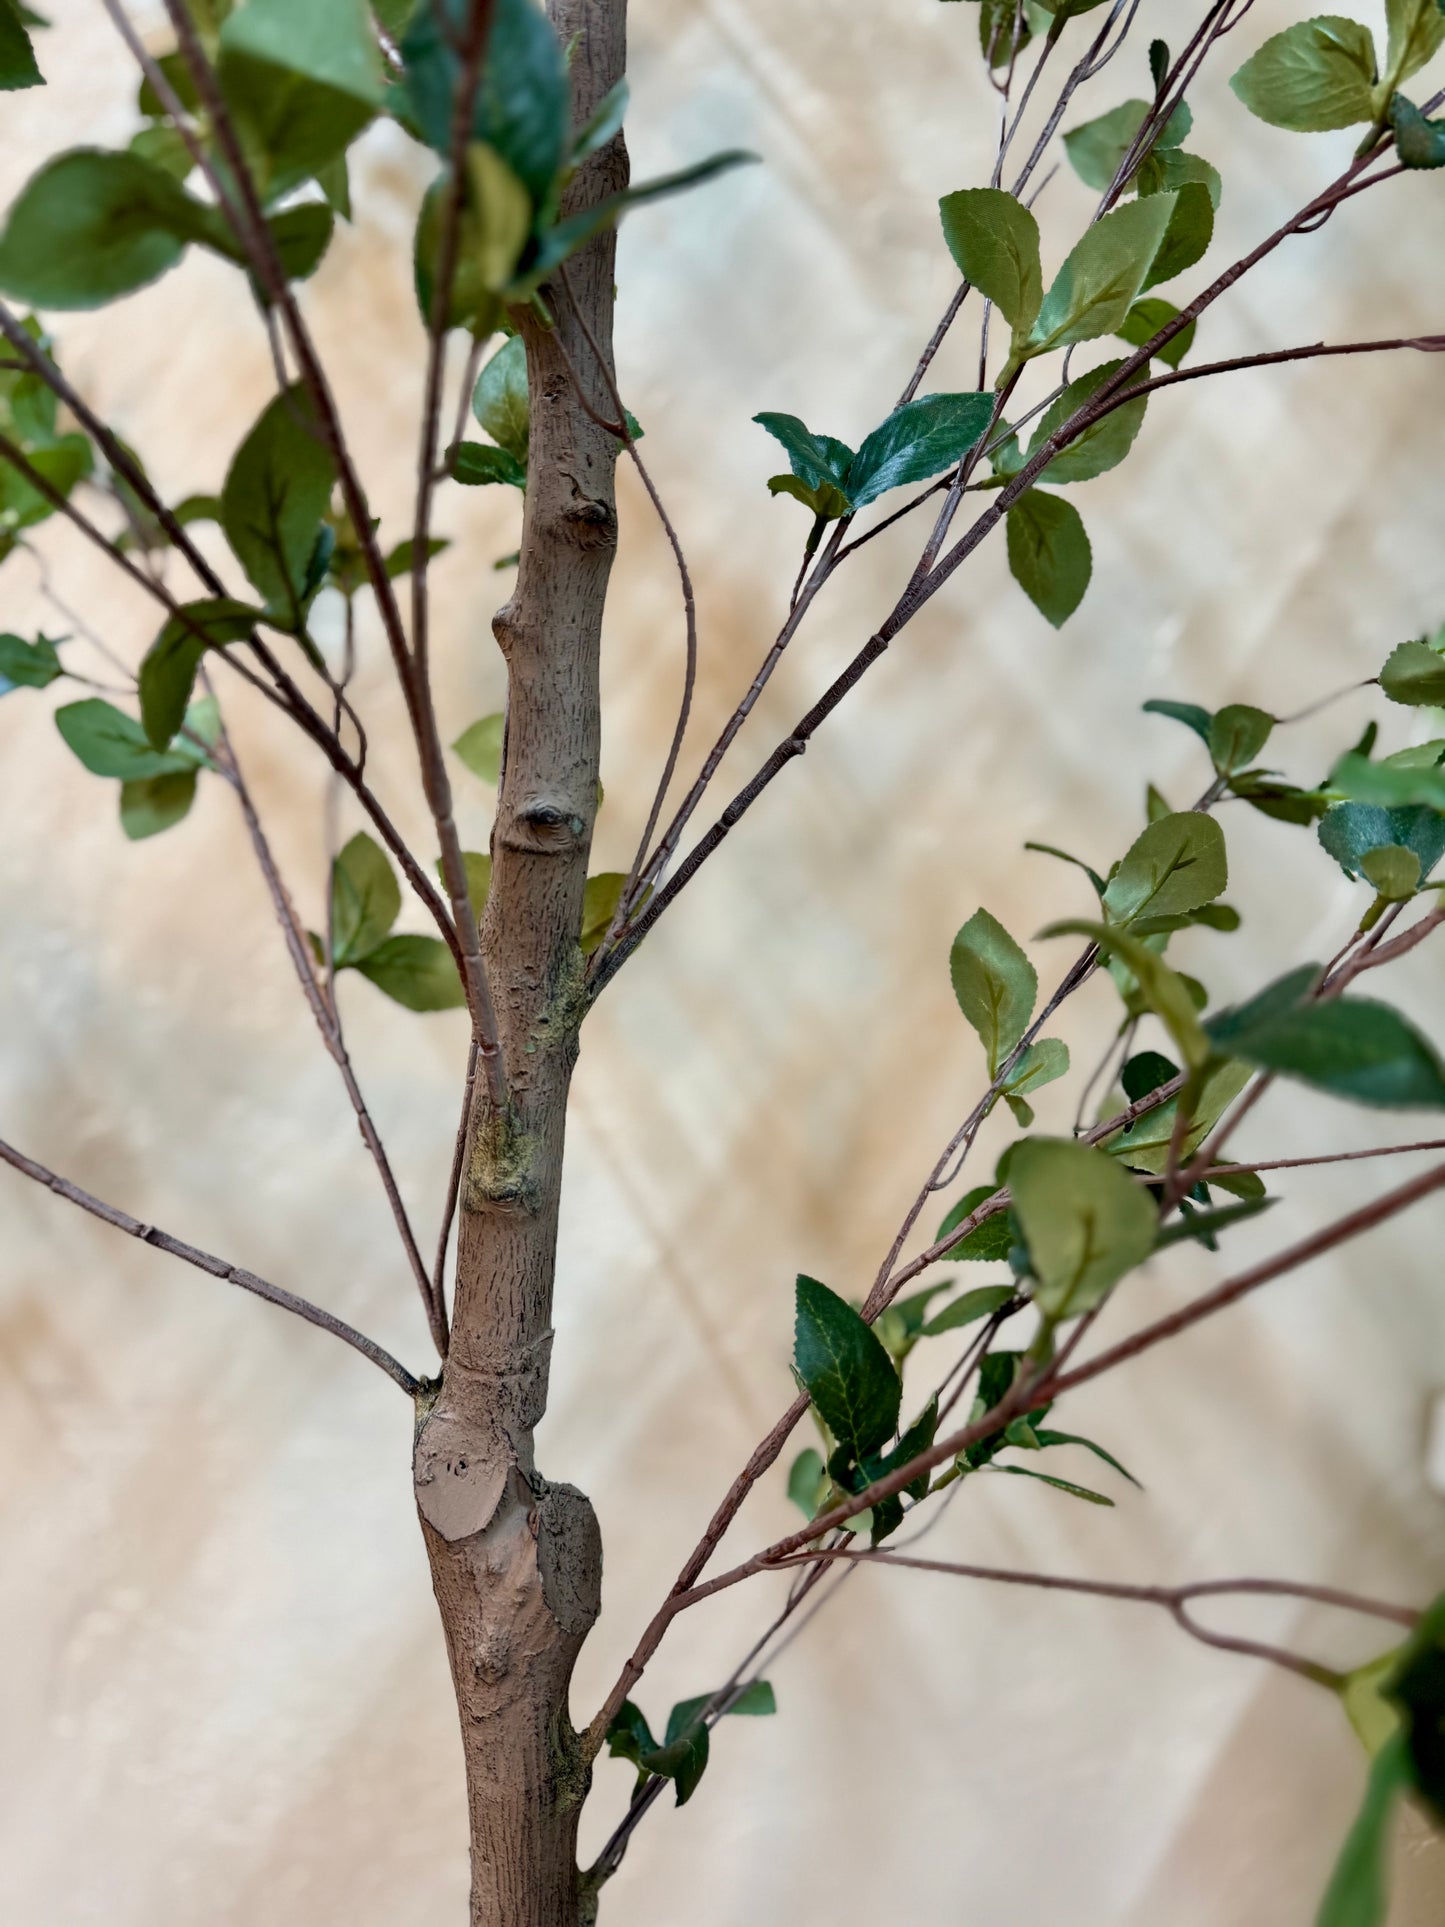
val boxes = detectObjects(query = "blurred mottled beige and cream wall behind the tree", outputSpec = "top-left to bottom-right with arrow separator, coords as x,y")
0,0 -> 1445,1927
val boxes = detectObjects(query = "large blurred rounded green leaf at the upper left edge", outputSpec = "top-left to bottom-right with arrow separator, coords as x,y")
0,148 -> 204,308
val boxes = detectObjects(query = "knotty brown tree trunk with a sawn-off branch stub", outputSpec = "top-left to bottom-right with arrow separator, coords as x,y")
414,0 -> 626,1927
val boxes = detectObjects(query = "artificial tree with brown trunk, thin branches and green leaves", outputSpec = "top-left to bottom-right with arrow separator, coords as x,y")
0,0 -> 1445,1927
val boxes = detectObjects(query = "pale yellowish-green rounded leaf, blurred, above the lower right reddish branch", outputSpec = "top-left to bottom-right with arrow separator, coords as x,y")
1008,1137 -> 1158,1320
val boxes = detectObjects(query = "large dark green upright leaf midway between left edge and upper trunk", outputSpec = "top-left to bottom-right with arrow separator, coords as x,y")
222,383 -> 337,628
